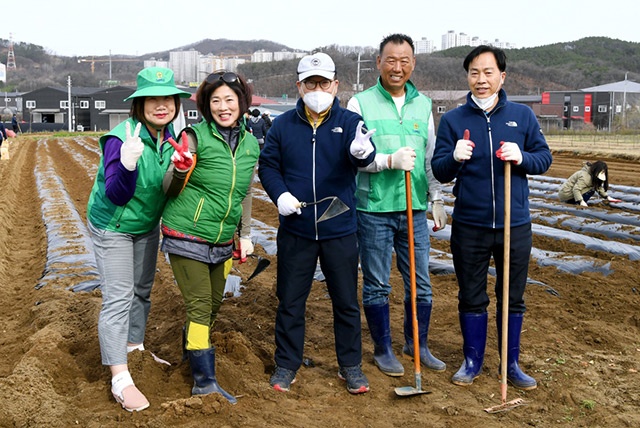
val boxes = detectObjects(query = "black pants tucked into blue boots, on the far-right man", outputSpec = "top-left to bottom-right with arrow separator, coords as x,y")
451,221 -> 532,313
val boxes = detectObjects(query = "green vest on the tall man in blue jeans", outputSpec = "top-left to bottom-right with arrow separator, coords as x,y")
355,79 -> 431,212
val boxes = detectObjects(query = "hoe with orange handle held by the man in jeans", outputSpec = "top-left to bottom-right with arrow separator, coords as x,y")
395,171 -> 431,397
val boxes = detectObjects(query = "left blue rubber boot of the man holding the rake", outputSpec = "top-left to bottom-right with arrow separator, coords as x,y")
451,312 -> 489,386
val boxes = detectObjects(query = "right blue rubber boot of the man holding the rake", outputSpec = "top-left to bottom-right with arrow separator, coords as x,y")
496,312 -> 538,391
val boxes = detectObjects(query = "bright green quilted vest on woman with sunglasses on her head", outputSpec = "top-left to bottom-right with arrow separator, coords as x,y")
162,121 -> 260,244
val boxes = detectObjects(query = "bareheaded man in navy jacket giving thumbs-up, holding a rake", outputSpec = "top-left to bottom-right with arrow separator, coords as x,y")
431,45 -> 551,390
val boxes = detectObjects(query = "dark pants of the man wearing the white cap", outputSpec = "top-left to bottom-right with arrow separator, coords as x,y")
275,228 -> 362,370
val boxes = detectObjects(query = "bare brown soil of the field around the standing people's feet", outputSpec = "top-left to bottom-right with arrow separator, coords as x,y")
0,137 -> 640,428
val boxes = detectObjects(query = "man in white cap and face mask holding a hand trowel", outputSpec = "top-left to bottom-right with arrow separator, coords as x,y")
258,53 -> 375,394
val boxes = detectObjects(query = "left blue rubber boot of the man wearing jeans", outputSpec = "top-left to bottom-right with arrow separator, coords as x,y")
364,303 -> 404,376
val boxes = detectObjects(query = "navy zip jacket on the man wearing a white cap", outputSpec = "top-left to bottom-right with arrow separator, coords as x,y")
258,98 -> 375,240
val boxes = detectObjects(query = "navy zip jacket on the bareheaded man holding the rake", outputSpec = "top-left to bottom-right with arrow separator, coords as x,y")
431,89 -> 552,229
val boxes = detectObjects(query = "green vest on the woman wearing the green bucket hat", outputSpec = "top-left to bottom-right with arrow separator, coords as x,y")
87,118 -> 174,235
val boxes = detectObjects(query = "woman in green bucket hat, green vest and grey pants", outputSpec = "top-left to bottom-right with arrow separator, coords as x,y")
87,67 -> 191,412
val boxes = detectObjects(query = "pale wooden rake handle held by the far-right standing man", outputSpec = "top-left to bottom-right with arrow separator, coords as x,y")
500,161 -> 511,404
